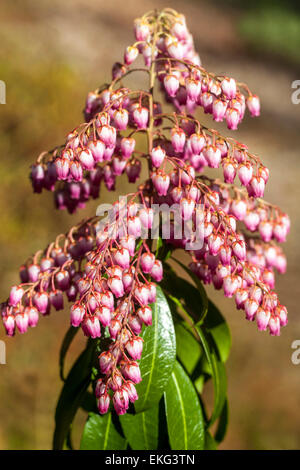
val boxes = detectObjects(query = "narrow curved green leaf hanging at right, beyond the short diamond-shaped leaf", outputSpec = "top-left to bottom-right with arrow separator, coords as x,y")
196,327 -> 227,425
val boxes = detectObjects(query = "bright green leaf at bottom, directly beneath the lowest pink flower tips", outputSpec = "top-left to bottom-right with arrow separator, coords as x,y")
80,413 -> 127,450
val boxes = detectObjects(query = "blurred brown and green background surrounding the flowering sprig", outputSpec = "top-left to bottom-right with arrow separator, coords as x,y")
0,0 -> 300,449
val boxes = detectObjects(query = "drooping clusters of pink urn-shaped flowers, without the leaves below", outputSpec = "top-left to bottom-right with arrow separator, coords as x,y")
2,9 -> 290,414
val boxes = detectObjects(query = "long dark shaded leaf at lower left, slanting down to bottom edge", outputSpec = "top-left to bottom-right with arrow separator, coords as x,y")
53,340 -> 96,450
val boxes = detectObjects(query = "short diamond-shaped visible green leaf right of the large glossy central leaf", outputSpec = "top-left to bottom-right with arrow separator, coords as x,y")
175,323 -> 202,375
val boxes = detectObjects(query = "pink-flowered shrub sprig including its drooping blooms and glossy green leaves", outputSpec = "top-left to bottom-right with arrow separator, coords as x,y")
1,8 -> 290,449
